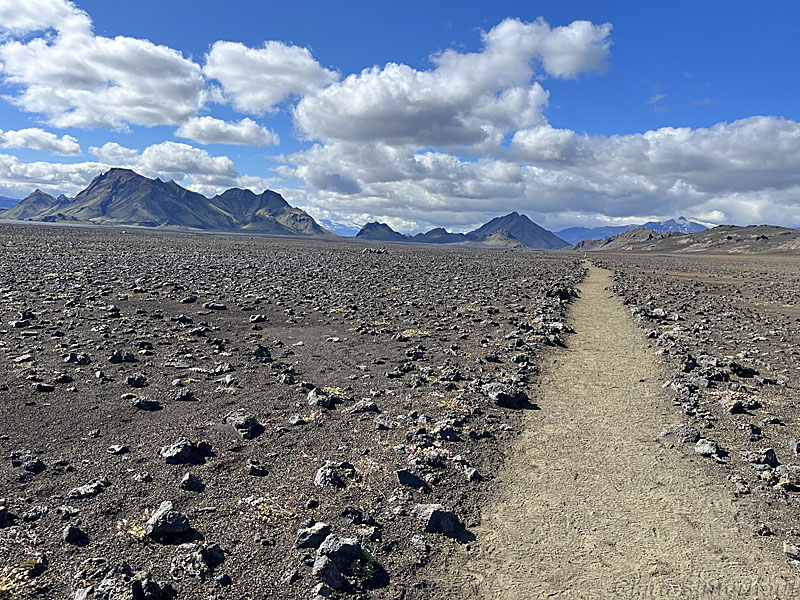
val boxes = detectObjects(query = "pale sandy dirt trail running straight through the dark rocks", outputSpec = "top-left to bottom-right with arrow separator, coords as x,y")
448,267 -> 800,600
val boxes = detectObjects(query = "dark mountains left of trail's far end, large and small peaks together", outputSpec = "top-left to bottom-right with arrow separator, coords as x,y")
0,168 -> 569,249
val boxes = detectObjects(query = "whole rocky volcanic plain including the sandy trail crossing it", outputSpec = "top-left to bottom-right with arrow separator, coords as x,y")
0,226 -> 800,600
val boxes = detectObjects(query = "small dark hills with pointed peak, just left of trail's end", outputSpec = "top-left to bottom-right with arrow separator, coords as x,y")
356,212 -> 569,250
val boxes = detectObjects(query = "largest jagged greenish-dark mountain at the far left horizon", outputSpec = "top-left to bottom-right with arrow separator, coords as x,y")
0,169 -> 337,238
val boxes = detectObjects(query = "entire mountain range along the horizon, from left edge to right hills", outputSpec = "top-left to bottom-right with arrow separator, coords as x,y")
0,168 -> 788,253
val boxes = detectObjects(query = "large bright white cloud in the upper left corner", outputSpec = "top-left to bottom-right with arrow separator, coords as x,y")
0,0 -> 204,129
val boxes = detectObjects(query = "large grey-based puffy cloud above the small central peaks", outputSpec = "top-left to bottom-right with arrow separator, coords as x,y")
295,19 -> 611,151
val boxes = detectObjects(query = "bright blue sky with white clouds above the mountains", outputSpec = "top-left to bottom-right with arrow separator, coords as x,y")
0,0 -> 800,233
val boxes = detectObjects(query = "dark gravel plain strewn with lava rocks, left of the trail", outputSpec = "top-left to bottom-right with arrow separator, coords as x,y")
0,227 -> 584,599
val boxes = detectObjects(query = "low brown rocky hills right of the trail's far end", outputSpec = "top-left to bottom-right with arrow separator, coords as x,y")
574,225 -> 800,254
